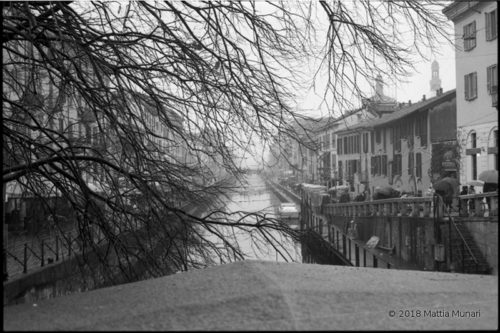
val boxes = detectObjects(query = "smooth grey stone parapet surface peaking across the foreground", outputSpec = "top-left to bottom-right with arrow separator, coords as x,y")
3,261 -> 498,330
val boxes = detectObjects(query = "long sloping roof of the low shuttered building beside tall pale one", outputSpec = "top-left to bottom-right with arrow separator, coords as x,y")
337,89 -> 456,134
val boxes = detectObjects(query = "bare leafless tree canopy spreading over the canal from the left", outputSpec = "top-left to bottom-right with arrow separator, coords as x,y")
2,1 -> 452,279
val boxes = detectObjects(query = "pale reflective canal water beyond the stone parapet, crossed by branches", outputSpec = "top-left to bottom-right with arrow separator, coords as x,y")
193,174 -> 302,263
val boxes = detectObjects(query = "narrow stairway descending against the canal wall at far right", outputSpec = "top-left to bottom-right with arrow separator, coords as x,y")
451,218 -> 491,274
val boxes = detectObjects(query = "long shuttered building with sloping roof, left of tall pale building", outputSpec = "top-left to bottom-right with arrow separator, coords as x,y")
337,90 -> 458,195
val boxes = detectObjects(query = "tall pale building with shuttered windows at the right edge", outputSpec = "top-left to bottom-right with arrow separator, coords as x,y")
443,1 -> 498,184
